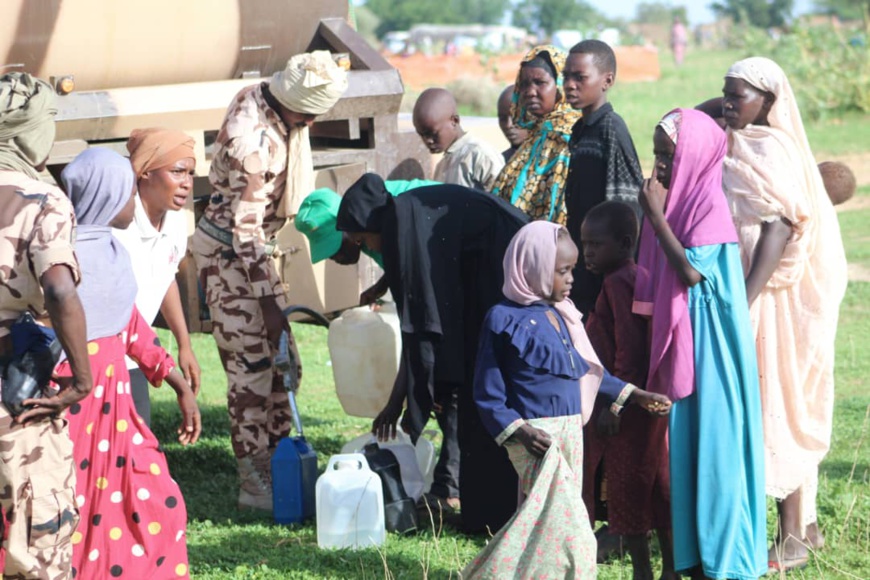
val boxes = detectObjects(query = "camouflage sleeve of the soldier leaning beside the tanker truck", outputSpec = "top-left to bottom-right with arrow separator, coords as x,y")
226,131 -> 283,298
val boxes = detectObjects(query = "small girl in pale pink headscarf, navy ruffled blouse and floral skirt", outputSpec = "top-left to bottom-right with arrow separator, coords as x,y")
462,221 -> 671,580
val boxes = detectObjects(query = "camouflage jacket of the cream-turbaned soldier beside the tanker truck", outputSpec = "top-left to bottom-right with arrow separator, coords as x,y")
190,85 -> 288,298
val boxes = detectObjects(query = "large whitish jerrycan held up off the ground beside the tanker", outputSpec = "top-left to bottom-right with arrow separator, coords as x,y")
327,303 -> 402,419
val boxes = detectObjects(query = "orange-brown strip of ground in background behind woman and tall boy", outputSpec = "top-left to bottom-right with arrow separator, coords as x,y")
387,46 -> 661,92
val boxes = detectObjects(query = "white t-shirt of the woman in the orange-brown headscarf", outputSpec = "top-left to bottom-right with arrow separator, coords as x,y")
112,195 -> 188,368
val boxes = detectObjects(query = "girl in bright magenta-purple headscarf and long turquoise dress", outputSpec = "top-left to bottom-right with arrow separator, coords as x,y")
633,109 -> 767,580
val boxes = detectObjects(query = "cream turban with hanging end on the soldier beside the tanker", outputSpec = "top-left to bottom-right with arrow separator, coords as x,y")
269,50 -> 347,218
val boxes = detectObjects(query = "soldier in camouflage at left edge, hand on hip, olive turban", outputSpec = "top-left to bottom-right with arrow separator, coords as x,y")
0,73 -> 92,579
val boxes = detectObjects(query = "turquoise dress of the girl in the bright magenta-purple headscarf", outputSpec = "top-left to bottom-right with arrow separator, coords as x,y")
670,244 -> 767,580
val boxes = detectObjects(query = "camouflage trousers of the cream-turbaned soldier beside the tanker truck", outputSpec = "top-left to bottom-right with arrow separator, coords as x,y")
196,256 -> 302,458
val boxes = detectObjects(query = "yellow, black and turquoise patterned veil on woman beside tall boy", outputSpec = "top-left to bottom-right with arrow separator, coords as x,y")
492,45 -> 582,225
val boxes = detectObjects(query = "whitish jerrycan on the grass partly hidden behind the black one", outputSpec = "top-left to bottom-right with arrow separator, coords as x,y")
341,430 -> 437,501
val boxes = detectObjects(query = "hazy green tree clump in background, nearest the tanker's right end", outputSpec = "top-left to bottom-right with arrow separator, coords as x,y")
365,0 -> 510,35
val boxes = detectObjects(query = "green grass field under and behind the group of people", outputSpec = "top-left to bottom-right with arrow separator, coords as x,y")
145,53 -> 870,580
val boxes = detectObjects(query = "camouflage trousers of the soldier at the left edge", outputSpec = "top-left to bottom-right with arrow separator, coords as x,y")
0,404 -> 79,579
